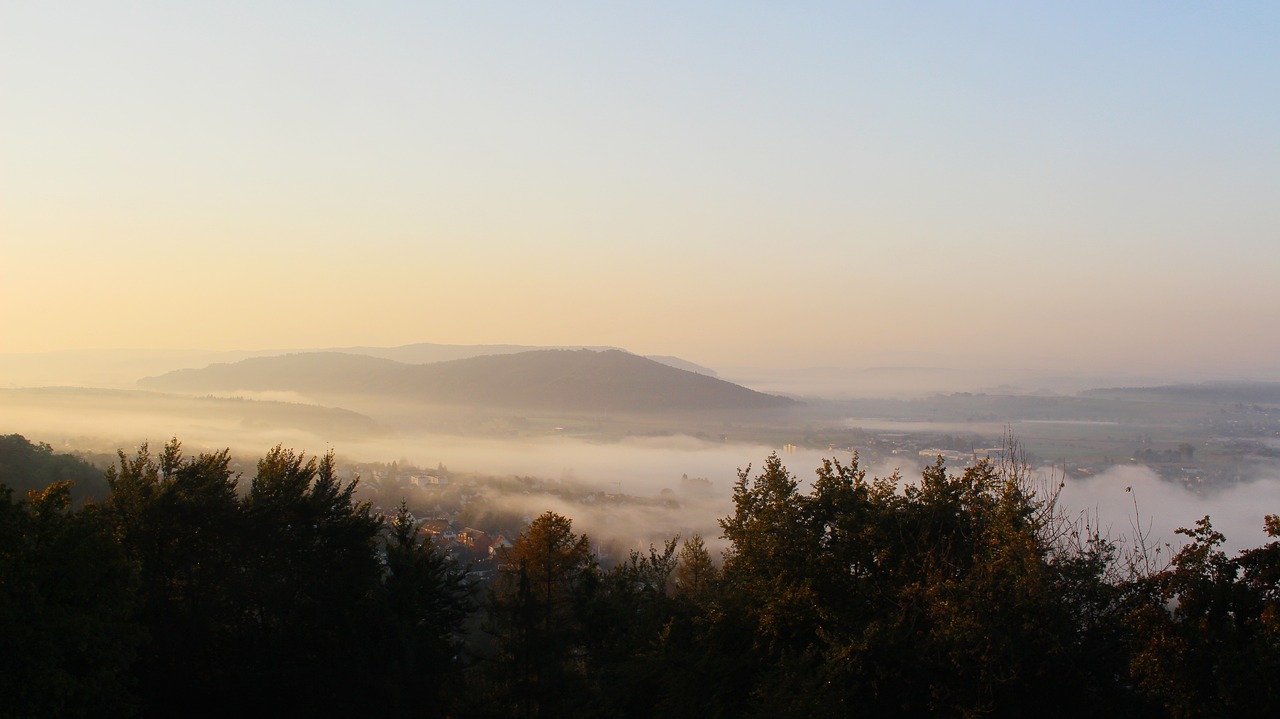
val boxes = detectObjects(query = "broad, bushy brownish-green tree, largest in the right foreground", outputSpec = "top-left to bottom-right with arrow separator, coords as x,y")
721,445 -> 1136,716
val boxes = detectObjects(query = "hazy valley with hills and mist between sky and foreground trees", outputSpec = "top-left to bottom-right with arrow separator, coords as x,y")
0,344 -> 1280,546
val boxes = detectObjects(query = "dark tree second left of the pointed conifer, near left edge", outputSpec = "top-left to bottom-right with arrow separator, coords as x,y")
104,438 -> 250,715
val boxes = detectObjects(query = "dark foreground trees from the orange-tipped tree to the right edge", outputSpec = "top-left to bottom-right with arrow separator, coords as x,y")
468,455 -> 1280,718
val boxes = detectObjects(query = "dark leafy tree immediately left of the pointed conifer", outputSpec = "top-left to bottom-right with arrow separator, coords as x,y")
241,445 -> 383,713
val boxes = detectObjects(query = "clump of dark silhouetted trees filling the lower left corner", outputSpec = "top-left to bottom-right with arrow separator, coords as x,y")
0,440 -> 472,716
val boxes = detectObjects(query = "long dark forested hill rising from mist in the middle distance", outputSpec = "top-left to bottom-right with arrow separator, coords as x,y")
138,349 -> 792,412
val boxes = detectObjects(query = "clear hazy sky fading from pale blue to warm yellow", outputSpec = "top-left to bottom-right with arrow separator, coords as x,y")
0,1 -> 1280,372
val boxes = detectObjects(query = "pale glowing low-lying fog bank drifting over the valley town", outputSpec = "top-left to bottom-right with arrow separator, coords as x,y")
0,386 -> 1280,560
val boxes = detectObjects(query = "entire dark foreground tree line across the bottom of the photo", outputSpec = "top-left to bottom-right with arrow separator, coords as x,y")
0,440 -> 1280,718
